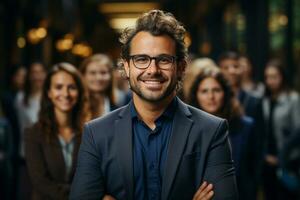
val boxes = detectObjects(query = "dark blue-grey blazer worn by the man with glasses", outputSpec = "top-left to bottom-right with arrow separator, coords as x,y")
70,99 -> 238,200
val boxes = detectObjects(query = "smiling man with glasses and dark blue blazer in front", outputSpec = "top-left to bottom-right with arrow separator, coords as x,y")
70,10 -> 237,200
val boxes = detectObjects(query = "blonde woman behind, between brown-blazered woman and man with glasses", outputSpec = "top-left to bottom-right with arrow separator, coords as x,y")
80,54 -> 117,119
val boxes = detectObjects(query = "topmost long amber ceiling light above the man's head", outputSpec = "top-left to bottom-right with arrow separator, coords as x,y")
99,2 -> 160,14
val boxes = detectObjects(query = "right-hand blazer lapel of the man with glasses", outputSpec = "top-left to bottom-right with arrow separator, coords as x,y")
162,99 -> 193,199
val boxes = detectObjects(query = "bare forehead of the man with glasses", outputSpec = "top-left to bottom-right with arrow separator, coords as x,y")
130,31 -> 176,56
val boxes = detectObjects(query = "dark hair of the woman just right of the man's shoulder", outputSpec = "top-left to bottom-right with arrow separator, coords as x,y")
189,67 -> 243,122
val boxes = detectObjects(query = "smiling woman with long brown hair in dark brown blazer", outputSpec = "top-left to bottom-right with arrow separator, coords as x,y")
25,63 -> 85,200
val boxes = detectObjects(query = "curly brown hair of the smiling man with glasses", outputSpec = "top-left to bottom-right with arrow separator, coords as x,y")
119,10 -> 188,88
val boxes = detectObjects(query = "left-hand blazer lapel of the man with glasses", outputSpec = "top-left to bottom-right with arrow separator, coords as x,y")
114,104 -> 134,199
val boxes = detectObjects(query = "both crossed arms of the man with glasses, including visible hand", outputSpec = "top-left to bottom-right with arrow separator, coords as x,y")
70,120 -> 237,200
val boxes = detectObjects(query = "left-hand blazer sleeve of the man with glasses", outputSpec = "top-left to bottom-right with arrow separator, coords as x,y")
70,124 -> 105,200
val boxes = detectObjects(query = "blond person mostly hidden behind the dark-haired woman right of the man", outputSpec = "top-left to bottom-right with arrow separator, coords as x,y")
182,58 -> 217,102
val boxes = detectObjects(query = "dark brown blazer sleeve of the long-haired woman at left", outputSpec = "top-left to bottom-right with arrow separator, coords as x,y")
24,128 -> 70,199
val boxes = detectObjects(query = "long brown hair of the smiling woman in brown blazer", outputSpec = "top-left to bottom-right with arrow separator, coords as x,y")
36,63 -> 86,140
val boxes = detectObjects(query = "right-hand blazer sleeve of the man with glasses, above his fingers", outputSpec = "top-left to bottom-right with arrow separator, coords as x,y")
204,121 -> 238,200
